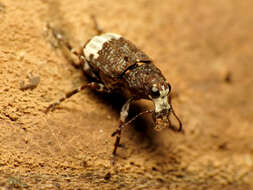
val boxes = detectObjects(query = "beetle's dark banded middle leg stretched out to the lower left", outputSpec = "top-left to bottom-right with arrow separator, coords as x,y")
45,82 -> 110,113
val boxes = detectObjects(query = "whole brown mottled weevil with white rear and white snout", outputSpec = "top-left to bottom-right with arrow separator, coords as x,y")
46,24 -> 182,163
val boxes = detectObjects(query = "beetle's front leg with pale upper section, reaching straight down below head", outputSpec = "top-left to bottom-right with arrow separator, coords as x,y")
112,97 -> 134,164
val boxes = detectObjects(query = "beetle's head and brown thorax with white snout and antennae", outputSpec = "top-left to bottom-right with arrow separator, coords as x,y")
124,62 -> 182,131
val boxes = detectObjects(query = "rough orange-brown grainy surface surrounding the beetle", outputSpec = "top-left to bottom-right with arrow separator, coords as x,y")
0,0 -> 253,190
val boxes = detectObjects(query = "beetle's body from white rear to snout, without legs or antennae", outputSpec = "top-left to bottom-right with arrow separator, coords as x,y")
83,33 -> 175,129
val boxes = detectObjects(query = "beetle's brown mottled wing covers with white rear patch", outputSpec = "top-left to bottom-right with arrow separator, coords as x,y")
83,33 -> 151,90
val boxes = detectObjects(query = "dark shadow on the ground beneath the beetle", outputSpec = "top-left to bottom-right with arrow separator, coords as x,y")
87,89 -> 170,157
